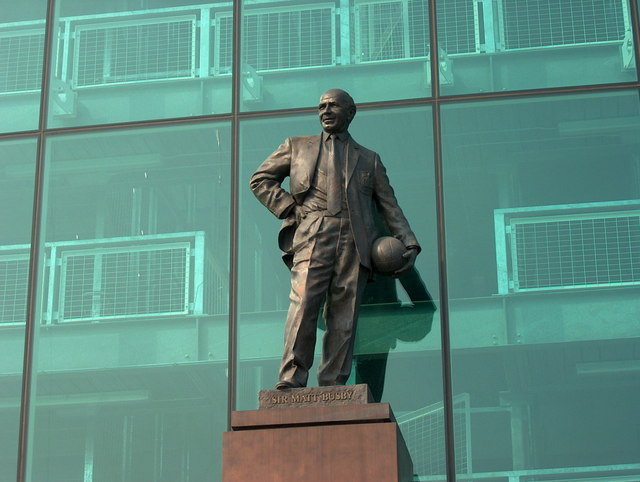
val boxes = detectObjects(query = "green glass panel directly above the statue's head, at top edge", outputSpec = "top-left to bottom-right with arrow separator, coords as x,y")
238,0 -> 431,111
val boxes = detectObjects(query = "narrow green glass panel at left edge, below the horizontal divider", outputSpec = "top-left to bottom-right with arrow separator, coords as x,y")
0,139 -> 37,480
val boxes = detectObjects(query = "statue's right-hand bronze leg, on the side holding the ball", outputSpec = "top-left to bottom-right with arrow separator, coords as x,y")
318,218 -> 368,385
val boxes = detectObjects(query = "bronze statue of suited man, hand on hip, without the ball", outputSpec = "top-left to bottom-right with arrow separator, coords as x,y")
250,89 -> 420,389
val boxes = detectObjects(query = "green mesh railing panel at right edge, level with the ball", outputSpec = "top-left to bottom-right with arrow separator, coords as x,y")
511,212 -> 640,291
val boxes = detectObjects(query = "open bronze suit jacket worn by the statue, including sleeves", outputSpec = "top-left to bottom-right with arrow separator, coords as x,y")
250,134 -> 420,270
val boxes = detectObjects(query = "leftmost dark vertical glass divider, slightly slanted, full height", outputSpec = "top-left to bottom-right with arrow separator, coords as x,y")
16,0 -> 55,482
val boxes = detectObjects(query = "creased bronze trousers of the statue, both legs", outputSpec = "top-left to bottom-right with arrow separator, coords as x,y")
280,213 -> 368,386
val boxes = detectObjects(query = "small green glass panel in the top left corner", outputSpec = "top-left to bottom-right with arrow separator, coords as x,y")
0,0 -> 47,132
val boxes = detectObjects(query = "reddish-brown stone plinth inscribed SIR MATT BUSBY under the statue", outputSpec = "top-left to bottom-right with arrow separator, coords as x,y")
222,385 -> 413,482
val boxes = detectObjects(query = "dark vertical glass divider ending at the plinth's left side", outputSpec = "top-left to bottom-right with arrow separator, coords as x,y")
227,0 -> 242,430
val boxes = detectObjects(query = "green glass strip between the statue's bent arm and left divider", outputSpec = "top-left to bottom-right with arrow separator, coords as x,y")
237,115 -> 320,400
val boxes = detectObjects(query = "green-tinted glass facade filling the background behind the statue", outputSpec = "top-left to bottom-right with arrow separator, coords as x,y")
0,0 -> 640,482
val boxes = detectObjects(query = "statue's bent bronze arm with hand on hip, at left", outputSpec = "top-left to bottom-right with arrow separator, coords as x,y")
249,139 -> 295,219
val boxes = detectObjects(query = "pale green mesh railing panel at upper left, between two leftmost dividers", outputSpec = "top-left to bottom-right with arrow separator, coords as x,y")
74,17 -> 196,87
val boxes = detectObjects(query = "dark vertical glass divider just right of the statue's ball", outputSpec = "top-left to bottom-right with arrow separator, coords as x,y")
429,0 -> 456,482
